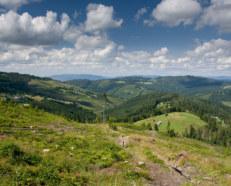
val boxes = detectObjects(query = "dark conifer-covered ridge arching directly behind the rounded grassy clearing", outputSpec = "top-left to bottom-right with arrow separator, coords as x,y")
107,93 -> 231,123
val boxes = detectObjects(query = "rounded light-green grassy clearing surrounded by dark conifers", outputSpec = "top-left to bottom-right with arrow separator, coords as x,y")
135,112 -> 206,134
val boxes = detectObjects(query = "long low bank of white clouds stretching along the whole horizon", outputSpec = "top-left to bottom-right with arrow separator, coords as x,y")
0,38 -> 231,76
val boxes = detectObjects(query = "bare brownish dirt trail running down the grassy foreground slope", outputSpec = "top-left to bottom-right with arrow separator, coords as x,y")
118,134 -> 188,186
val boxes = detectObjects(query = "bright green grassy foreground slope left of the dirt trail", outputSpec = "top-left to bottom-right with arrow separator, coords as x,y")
0,101 -> 148,186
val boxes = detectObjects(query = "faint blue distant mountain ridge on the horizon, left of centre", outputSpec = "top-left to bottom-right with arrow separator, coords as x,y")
51,74 -> 109,81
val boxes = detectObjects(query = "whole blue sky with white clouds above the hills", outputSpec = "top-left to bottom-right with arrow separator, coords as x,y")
0,0 -> 231,76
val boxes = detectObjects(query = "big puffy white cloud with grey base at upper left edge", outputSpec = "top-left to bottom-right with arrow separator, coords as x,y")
0,11 -> 70,45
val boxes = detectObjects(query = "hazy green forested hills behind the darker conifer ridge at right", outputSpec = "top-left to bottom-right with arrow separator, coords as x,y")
68,76 -> 231,106
